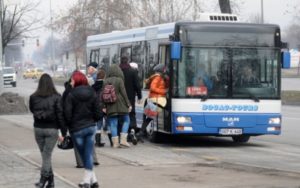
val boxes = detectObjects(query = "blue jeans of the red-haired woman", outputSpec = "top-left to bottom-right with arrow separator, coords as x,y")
71,126 -> 96,170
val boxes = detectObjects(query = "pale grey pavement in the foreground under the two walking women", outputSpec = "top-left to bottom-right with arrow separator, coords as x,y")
0,114 -> 300,188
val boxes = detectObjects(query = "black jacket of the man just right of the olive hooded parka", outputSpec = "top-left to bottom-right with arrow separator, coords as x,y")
120,63 -> 142,103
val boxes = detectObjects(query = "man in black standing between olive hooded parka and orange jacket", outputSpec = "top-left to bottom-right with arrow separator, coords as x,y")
120,56 -> 142,134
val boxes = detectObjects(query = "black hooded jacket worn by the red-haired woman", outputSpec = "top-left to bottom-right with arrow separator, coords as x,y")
64,86 -> 100,132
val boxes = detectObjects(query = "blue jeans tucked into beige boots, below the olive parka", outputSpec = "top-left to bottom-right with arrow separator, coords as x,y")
107,114 -> 130,137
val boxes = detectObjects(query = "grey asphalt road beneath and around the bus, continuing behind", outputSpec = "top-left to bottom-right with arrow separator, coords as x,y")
4,77 -> 300,174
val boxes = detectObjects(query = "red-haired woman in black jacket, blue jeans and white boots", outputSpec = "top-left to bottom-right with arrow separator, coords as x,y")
64,71 -> 100,188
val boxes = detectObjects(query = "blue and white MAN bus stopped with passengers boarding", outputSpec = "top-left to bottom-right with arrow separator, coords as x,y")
87,14 -> 281,142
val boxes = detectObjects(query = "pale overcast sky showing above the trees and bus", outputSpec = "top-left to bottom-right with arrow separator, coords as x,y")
4,0 -> 300,56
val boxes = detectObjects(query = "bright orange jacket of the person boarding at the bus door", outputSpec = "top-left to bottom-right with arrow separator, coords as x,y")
149,73 -> 168,98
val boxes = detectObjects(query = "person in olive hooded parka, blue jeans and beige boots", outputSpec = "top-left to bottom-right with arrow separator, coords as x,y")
103,64 -> 132,148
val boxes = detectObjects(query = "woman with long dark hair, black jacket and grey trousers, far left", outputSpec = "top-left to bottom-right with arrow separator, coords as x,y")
29,74 -> 67,188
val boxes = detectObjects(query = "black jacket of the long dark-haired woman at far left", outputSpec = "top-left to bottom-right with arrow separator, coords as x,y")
29,94 -> 67,135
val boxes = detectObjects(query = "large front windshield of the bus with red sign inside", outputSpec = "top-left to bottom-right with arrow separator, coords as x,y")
173,47 -> 280,99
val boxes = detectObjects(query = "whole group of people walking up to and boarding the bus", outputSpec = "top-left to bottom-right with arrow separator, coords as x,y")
29,56 -> 168,188
